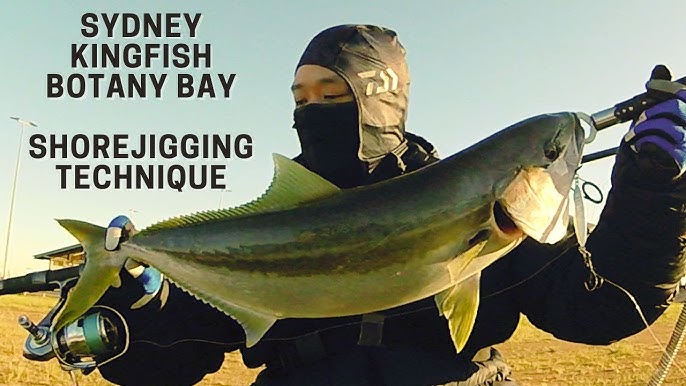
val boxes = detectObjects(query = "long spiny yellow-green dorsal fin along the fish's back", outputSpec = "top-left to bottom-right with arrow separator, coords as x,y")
140,153 -> 341,234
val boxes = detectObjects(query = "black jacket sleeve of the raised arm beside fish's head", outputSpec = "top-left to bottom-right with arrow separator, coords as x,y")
511,148 -> 686,344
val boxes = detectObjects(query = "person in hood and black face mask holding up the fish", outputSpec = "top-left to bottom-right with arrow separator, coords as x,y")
94,25 -> 686,386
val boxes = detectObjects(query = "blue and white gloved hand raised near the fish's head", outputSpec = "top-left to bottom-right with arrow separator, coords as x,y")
623,68 -> 686,182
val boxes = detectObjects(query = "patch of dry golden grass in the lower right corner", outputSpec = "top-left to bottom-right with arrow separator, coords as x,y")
498,305 -> 686,386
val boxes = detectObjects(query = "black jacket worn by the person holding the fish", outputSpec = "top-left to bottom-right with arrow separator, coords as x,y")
100,139 -> 686,386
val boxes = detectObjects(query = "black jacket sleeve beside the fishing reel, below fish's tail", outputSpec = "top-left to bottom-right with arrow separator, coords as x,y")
98,273 -> 245,385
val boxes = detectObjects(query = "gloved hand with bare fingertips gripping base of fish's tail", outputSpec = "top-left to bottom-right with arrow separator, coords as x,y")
105,215 -> 169,310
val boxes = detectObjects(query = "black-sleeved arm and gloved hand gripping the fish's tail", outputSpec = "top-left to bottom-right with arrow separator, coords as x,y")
93,216 -> 245,385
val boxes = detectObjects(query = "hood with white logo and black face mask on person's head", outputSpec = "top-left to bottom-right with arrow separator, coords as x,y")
295,25 -> 410,187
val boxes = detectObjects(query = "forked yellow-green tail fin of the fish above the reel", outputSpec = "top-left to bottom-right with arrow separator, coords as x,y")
52,220 -> 126,331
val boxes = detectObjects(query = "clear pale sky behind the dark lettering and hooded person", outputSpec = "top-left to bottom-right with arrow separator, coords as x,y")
0,0 -> 686,276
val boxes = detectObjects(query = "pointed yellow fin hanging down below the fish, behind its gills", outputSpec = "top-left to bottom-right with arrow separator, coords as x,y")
434,272 -> 481,353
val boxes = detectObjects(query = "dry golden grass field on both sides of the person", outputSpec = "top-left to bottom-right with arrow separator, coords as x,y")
0,295 -> 686,386
